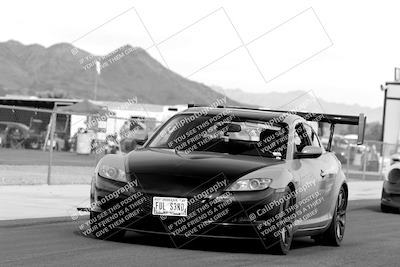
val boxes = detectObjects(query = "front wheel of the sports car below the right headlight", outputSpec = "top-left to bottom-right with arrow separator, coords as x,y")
271,187 -> 295,255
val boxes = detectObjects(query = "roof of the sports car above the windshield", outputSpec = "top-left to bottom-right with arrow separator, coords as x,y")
181,107 -> 305,125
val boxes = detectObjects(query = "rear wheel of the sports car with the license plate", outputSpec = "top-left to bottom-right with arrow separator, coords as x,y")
318,186 -> 348,247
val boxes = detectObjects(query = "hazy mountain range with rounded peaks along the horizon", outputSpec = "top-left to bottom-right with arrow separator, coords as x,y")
0,40 -> 382,122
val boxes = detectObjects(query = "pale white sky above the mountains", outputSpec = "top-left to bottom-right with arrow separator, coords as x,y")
0,0 -> 400,107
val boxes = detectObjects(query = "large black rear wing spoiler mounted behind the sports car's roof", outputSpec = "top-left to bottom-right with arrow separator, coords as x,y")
188,104 -> 367,150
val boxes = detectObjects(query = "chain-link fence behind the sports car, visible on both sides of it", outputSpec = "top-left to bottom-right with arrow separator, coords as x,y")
0,105 -> 400,185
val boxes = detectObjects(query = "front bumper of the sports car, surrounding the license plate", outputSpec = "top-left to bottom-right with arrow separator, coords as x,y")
91,177 -> 283,239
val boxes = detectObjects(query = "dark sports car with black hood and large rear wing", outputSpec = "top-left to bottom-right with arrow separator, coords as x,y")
86,107 -> 365,254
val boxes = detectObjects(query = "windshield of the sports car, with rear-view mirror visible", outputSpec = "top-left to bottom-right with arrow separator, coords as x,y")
148,114 -> 288,159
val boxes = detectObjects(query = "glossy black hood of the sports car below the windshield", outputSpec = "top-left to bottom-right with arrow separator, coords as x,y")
127,148 -> 284,196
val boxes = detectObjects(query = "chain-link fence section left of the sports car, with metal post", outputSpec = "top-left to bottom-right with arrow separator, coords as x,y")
0,105 -> 160,185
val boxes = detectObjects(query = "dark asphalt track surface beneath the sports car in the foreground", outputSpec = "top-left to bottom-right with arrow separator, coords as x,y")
0,200 -> 400,266
